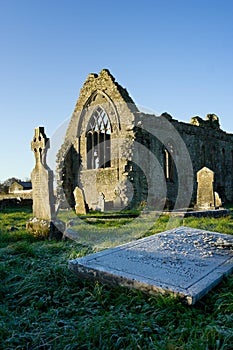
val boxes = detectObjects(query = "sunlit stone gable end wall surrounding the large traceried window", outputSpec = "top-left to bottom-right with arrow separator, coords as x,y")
57,70 -> 137,209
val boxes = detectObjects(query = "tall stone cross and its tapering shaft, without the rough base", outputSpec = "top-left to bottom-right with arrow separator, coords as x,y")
31,127 -> 55,221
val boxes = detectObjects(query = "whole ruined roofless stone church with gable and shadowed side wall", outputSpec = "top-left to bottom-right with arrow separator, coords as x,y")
57,69 -> 233,210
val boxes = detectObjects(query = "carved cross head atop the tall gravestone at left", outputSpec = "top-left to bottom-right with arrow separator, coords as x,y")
31,126 -> 49,166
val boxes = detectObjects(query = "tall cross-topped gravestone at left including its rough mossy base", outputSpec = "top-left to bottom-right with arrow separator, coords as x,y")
26,127 -> 65,239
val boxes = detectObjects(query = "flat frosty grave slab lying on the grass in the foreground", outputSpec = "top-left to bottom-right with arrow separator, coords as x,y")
69,227 -> 233,305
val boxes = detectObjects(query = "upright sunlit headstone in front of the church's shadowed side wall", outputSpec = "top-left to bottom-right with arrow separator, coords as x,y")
196,167 -> 215,210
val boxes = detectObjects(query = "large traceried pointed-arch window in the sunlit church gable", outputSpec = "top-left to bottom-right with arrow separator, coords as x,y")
86,107 -> 111,169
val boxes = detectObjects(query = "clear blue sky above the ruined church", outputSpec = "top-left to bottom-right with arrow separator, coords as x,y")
0,0 -> 233,181
